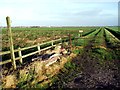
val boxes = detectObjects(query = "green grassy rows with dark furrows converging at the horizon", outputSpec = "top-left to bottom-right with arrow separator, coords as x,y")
77,27 -> 120,47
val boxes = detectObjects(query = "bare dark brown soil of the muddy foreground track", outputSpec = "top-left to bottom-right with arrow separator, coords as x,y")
50,34 -> 120,89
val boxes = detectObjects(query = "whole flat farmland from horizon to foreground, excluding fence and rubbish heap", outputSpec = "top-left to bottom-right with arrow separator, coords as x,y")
2,27 -> 120,89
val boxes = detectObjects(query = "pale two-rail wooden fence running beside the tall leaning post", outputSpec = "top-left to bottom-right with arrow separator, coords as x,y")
0,38 -> 62,65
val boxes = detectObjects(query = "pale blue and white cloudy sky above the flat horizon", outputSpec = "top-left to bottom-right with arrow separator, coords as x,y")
0,0 -> 119,26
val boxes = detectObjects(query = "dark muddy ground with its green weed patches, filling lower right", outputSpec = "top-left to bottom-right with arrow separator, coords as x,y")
48,34 -> 120,89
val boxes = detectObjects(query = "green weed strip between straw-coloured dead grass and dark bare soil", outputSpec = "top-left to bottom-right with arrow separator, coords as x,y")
49,56 -> 80,89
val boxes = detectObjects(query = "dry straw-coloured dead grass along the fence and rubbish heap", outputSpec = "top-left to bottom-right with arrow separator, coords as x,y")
2,54 -> 75,88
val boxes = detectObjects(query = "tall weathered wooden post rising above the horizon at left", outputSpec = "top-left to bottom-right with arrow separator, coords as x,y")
6,16 -> 16,69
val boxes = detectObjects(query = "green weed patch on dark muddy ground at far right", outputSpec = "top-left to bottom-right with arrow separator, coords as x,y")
91,48 -> 118,66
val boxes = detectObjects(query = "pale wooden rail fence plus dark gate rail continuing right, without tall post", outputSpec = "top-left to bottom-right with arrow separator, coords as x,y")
0,34 -> 111,68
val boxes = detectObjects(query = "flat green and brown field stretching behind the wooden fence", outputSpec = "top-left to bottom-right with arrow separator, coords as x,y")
2,27 -> 99,51
